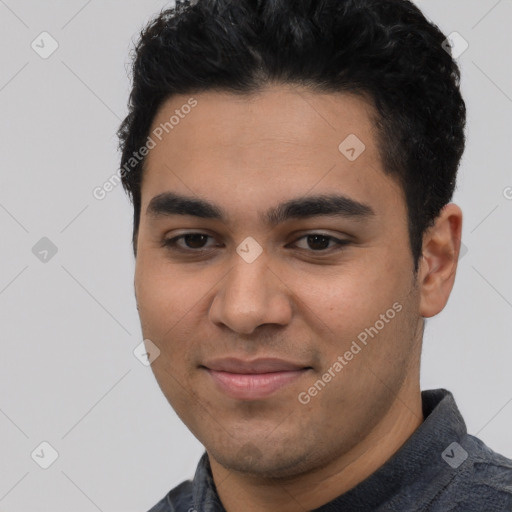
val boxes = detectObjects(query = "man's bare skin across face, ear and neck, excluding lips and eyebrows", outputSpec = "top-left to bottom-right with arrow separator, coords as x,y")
134,84 -> 462,512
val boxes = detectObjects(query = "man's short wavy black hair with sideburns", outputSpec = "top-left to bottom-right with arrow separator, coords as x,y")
118,0 -> 466,273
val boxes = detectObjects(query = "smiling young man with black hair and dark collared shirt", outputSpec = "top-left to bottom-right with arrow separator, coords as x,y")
119,0 -> 512,512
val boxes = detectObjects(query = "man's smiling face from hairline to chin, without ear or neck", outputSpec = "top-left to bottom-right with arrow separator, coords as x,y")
135,86 -> 422,476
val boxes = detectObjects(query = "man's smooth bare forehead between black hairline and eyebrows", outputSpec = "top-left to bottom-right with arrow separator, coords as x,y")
142,86 -> 401,224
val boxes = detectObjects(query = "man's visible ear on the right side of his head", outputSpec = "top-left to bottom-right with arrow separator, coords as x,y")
418,203 -> 462,318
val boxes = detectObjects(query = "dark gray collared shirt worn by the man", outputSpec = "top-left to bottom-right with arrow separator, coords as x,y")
149,389 -> 512,512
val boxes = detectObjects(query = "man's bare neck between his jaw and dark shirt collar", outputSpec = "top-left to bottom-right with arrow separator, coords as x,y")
209,382 -> 424,512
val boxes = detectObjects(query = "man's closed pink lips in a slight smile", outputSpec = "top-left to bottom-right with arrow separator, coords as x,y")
203,358 -> 311,400
